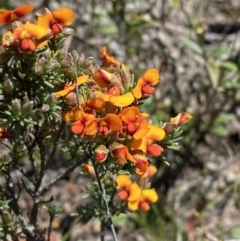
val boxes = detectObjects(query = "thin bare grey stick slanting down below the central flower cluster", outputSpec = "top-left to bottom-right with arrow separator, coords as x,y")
91,153 -> 118,241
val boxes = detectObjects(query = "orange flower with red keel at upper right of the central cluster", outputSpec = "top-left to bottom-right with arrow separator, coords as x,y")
132,69 -> 160,99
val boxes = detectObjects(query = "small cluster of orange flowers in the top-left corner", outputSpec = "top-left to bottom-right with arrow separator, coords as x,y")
0,4 -> 74,53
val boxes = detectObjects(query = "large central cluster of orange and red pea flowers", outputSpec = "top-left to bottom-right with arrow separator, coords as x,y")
54,47 -> 191,211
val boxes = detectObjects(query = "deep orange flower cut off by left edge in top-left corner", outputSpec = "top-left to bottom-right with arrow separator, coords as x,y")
0,4 -> 34,23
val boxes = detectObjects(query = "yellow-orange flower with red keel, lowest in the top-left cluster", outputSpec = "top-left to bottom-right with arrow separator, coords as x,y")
2,22 -> 49,51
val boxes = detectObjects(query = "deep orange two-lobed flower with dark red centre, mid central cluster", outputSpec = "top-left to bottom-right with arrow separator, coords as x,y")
86,113 -> 122,136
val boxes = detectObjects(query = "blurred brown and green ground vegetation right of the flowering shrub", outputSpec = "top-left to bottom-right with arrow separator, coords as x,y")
1,0 -> 240,241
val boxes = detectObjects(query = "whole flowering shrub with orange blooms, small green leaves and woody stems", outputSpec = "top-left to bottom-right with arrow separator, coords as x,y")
0,4 -> 192,240
